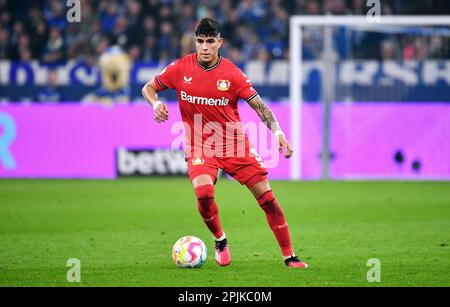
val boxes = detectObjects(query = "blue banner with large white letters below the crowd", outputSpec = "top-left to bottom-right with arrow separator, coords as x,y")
0,60 -> 450,102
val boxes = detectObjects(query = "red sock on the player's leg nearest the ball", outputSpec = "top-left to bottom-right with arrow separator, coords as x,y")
195,184 -> 223,238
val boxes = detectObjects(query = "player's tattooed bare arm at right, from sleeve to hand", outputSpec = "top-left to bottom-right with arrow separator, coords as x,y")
247,95 -> 294,158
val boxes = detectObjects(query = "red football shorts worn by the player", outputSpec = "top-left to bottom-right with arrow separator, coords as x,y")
187,154 -> 267,188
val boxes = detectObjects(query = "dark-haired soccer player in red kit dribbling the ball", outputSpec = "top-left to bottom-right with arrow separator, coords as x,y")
142,18 -> 308,268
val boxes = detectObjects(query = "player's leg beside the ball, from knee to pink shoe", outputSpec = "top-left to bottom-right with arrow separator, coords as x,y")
192,174 -> 231,266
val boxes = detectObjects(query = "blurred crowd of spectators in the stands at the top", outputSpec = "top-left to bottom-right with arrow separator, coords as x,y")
0,0 -> 450,64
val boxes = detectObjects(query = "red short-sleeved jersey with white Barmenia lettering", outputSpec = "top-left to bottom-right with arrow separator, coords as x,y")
155,53 -> 258,157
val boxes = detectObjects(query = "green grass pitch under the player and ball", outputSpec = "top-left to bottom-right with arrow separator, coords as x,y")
0,178 -> 450,287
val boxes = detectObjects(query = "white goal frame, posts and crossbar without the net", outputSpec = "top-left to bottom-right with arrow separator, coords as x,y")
289,15 -> 450,180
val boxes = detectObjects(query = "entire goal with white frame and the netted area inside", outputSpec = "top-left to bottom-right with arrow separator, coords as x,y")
289,16 -> 450,180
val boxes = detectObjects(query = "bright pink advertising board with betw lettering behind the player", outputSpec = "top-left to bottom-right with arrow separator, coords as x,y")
0,103 -> 450,179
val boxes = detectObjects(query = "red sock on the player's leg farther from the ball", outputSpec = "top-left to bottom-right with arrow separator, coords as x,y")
257,190 -> 293,257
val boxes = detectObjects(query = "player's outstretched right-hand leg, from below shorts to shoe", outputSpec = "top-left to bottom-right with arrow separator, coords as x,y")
246,178 -> 308,268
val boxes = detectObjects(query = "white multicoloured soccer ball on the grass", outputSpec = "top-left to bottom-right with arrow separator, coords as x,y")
172,236 -> 208,268
